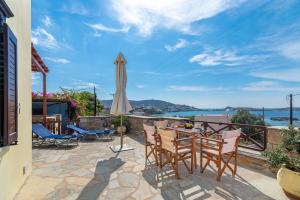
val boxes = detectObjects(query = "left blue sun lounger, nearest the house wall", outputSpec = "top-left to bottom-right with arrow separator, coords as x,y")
32,124 -> 80,146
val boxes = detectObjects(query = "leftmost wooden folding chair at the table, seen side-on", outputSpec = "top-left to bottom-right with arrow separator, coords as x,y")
143,124 -> 158,166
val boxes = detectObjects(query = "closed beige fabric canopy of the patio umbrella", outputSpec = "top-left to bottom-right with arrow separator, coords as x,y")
110,52 -> 132,115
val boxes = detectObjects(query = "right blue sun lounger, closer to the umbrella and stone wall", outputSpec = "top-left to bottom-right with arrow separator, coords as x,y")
67,124 -> 115,140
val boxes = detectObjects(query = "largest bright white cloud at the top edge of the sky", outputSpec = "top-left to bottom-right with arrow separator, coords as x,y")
111,0 -> 244,36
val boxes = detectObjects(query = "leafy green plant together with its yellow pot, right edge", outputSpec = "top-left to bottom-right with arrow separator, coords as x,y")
265,127 -> 300,199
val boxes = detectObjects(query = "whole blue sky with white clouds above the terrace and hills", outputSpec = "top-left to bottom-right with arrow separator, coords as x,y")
32,0 -> 300,108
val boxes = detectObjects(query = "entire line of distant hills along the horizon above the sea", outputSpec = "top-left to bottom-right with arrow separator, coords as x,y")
101,99 -> 300,115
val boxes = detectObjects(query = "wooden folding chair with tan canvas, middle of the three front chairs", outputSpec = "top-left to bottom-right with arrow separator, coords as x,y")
157,129 -> 194,179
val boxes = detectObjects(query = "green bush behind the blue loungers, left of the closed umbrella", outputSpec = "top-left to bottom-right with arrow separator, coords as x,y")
62,89 -> 103,118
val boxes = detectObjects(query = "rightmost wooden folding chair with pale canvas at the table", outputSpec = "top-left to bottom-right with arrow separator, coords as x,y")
200,129 -> 241,181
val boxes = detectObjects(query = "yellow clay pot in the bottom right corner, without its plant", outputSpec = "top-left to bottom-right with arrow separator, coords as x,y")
277,166 -> 300,199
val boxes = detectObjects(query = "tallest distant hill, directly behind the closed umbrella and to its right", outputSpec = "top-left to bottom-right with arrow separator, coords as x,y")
101,100 -> 199,113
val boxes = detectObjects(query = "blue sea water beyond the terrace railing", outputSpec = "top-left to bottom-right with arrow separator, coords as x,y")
156,110 -> 300,127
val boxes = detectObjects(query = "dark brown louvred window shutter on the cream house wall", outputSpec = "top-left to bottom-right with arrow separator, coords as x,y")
0,0 -> 18,146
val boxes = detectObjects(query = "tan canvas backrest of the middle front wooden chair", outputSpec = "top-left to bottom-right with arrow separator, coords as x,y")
157,129 -> 176,152
